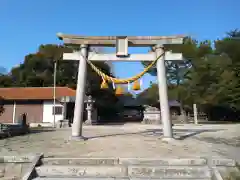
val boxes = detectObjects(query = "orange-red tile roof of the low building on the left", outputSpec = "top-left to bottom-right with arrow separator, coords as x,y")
0,87 -> 76,100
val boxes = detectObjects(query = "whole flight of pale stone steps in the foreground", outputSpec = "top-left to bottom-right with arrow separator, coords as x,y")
36,157 -> 236,180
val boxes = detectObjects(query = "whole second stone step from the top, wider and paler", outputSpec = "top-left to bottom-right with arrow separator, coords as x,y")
36,165 -> 212,179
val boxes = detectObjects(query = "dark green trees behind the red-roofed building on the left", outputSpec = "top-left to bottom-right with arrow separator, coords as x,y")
0,44 -> 118,116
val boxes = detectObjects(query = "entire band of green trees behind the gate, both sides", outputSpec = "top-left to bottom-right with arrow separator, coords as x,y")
0,29 -> 240,120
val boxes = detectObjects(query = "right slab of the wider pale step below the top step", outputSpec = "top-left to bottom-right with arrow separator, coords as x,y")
128,166 -> 212,179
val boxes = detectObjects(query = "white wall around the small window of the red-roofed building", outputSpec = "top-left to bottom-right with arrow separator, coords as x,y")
43,101 -> 64,123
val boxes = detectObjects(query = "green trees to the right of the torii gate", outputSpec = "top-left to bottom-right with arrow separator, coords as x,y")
139,30 -> 240,119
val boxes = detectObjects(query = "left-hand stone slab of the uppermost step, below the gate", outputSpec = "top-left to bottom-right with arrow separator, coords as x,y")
42,158 -> 118,165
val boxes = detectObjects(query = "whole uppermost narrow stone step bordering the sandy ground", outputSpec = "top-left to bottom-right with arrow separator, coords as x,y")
42,157 -> 207,166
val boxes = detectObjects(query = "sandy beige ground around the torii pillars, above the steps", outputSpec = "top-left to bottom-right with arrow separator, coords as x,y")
0,124 -> 240,162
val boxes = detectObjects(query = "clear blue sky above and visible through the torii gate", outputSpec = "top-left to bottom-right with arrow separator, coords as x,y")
0,0 -> 240,90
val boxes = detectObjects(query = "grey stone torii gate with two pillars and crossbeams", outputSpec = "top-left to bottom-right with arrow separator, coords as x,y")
57,33 -> 184,139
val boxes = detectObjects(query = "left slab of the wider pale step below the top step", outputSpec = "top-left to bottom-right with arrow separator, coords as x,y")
36,166 -> 127,177
